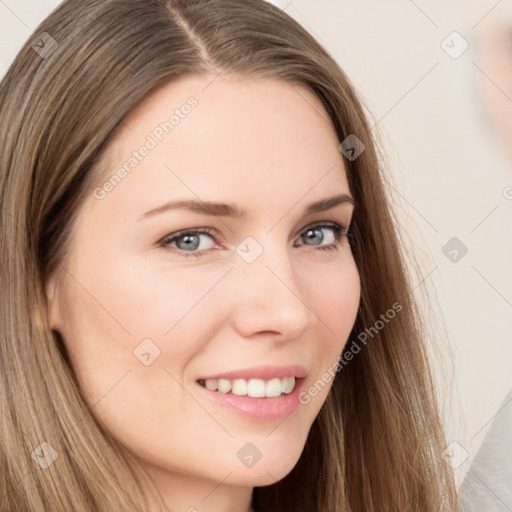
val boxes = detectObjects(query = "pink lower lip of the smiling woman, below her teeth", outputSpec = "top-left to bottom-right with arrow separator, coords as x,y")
196,379 -> 305,420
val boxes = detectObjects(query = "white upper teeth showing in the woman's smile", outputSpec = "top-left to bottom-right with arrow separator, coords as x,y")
202,377 -> 295,398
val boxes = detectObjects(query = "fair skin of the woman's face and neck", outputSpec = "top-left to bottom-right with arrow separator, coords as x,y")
47,75 -> 360,512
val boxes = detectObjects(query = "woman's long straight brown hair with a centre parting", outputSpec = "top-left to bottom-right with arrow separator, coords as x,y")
0,0 -> 456,512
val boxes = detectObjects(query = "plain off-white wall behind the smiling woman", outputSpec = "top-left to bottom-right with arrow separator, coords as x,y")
0,0 -> 512,488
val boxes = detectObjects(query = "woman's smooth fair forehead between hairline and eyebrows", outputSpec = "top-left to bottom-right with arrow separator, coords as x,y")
90,75 -> 348,218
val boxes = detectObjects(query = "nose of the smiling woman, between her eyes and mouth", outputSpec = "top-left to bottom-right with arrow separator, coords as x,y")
231,243 -> 316,339
